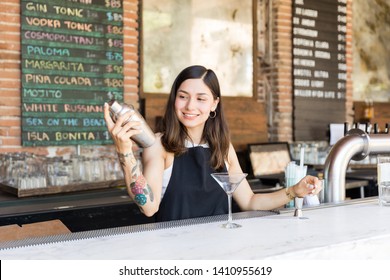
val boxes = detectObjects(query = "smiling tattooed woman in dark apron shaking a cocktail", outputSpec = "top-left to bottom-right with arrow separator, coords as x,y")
104,65 -> 321,221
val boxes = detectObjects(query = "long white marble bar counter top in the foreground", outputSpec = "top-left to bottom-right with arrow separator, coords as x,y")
0,198 -> 390,260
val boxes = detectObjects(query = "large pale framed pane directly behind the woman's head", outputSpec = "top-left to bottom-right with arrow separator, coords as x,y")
142,0 -> 253,96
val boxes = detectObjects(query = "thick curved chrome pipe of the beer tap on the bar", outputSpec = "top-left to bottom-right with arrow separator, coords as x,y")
324,128 -> 390,202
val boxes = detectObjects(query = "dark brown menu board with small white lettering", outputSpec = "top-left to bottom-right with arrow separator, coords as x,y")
292,0 -> 347,141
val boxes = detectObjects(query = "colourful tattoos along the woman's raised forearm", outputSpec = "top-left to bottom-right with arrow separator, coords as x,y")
118,153 -> 154,206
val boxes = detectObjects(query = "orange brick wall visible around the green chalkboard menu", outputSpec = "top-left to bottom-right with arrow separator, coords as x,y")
0,0 -> 139,155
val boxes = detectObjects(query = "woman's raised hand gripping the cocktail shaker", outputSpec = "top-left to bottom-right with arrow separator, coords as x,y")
104,103 -> 141,153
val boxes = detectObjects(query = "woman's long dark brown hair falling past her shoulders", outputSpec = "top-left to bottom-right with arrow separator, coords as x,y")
161,65 -> 230,170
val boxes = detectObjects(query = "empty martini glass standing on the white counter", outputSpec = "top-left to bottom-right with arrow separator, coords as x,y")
211,172 -> 248,228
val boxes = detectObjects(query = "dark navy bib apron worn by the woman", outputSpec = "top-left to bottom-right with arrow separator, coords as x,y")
156,146 -> 228,222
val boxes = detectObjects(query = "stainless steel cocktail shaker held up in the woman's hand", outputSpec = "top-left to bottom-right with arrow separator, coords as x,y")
108,100 -> 156,148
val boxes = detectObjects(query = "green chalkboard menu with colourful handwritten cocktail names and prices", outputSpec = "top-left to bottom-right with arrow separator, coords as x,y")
21,0 -> 123,146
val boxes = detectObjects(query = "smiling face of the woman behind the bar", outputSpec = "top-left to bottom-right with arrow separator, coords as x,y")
175,79 -> 219,130
